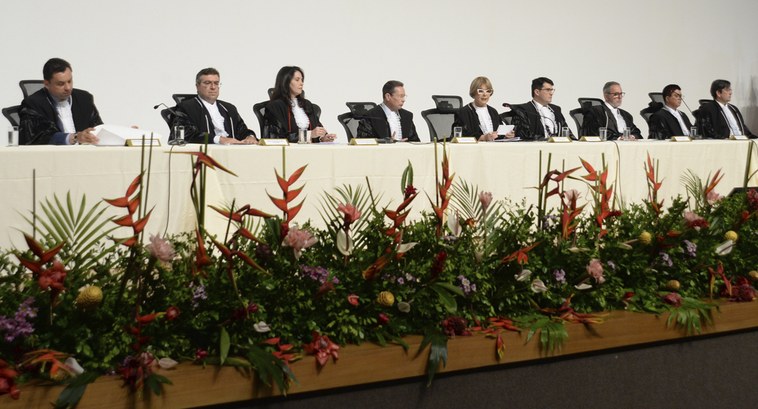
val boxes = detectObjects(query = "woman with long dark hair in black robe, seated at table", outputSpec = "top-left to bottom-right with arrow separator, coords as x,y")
265,67 -> 335,143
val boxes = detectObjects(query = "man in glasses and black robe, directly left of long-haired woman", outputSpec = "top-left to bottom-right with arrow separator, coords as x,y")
174,68 -> 258,145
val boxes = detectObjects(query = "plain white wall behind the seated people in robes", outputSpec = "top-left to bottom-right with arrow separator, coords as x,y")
0,0 -> 758,140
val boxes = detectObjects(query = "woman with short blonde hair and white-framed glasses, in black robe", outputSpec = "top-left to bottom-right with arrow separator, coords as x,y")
453,77 -> 515,142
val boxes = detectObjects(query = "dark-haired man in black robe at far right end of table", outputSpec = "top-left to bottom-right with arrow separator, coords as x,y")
696,80 -> 756,139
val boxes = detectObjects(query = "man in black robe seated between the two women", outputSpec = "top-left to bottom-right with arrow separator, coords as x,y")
358,81 -> 420,142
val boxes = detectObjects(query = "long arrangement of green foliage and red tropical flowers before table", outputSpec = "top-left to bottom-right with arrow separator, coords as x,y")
0,143 -> 758,407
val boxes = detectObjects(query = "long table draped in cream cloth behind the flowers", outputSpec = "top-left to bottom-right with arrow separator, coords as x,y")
0,140 -> 758,248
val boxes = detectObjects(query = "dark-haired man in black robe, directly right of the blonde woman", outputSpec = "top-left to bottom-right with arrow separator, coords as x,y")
512,77 -> 573,140
